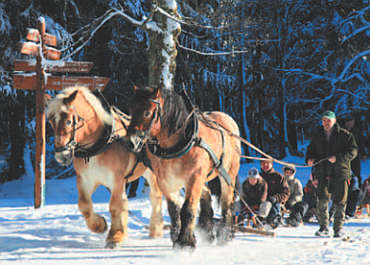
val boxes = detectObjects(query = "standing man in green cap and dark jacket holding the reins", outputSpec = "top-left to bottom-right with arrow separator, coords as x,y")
306,111 -> 357,237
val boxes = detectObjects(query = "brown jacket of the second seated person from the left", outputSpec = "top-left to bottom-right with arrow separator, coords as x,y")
261,169 -> 290,204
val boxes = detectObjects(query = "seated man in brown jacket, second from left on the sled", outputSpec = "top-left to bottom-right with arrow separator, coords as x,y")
261,159 -> 290,228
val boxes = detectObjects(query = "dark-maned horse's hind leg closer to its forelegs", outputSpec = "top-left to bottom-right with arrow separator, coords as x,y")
198,186 -> 215,243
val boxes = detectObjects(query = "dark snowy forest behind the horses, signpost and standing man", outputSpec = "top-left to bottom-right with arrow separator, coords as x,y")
0,0 -> 370,183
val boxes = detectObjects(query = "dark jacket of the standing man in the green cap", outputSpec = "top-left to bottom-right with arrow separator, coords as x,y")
306,123 -> 357,181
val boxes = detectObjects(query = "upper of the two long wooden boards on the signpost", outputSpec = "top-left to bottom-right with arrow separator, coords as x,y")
14,59 -> 94,73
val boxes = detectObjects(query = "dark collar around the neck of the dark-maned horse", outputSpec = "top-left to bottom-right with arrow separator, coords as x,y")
148,112 -> 198,159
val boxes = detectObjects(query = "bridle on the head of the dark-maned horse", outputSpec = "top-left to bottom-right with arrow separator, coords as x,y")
132,99 -> 161,152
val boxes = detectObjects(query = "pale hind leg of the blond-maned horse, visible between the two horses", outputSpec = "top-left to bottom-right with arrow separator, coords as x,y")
144,170 -> 163,238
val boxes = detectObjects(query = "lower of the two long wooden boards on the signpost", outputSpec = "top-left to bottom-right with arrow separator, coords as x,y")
13,74 -> 109,91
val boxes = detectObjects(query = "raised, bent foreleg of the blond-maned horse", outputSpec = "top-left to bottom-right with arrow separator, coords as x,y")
77,175 -> 107,233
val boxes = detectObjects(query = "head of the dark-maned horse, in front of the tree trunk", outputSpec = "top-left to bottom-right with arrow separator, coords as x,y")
127,84 -> 162,152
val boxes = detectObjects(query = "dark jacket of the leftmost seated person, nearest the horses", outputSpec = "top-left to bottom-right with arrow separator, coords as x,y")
242,178 -> 267,209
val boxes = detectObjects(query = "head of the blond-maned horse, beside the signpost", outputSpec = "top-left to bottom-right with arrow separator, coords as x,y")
47,87 -> 112,166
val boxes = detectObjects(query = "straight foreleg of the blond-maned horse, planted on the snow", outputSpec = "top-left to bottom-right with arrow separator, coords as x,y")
105,183 -> 128,248
